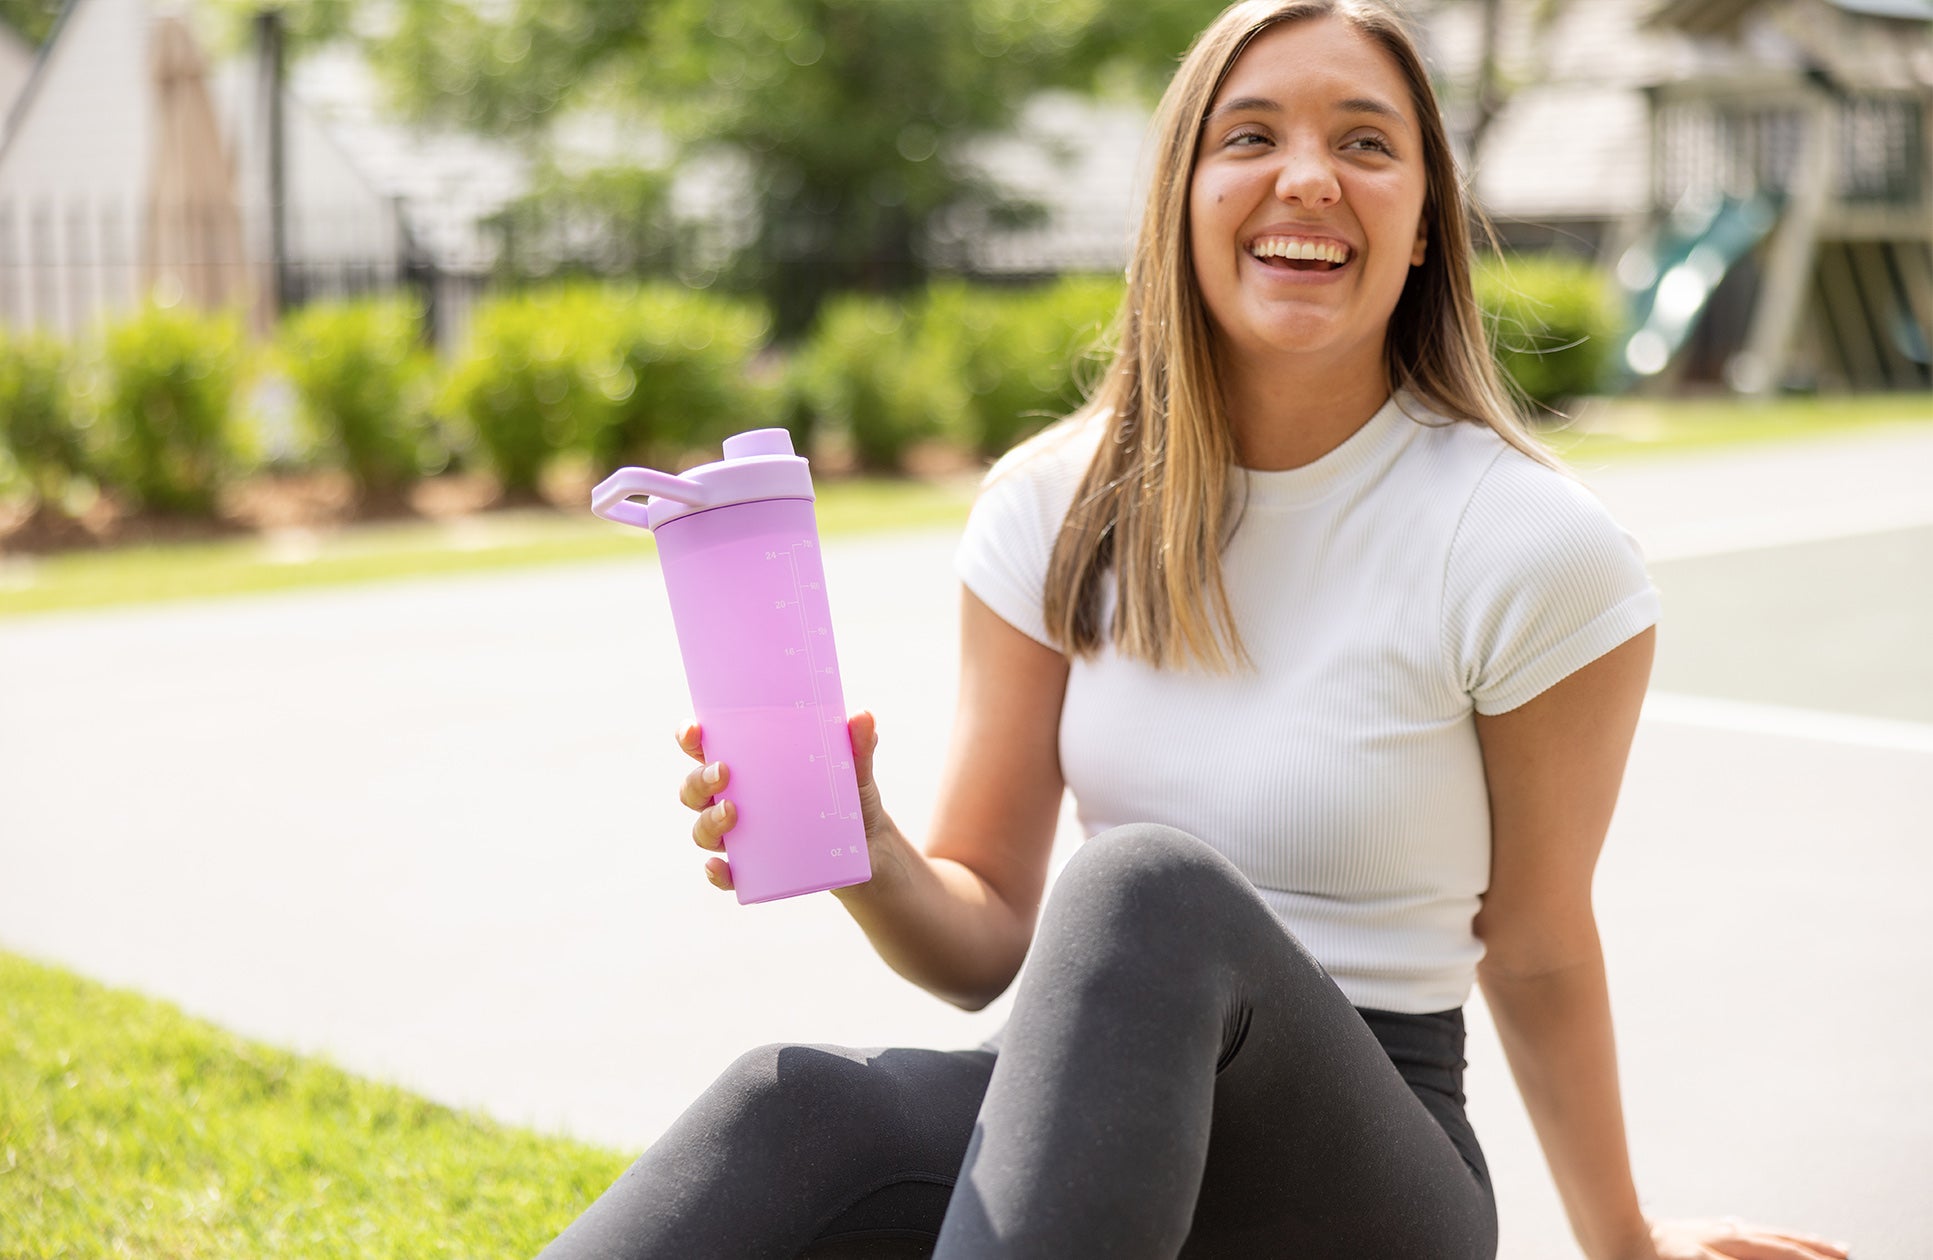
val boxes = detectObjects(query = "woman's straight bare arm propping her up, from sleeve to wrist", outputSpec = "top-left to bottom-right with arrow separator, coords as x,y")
1475,630 -> 1655,1260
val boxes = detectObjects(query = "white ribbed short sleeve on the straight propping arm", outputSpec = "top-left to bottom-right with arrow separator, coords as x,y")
1444,448 -> 1659,715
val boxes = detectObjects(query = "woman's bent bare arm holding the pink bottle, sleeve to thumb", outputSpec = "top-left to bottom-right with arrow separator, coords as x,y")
835,589 -> 1067,1011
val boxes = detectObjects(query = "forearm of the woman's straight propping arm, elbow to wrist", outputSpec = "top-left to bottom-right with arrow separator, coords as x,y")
1477,933 -> 1651,1260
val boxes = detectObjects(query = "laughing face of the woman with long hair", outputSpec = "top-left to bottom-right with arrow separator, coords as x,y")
1189,17 -> 1427,371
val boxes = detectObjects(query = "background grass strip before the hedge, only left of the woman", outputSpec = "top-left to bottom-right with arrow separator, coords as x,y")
0,479 -> 974,616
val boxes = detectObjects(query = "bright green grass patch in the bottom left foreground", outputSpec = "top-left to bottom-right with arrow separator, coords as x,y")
0,953 -> 628,1260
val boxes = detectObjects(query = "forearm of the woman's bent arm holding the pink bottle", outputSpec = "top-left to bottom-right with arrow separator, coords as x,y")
833,815 -> 1032,1011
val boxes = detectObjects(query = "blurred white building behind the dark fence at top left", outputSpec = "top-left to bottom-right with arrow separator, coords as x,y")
0,0 -> 414,334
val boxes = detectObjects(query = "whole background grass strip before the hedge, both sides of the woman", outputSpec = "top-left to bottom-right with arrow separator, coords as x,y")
0,394 -> 1933,616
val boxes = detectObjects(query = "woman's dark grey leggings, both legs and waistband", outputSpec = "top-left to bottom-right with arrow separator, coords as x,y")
543,825 -> 1496,1260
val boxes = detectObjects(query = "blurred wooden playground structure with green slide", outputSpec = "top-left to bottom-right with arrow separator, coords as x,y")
1616,0 -> 1933,394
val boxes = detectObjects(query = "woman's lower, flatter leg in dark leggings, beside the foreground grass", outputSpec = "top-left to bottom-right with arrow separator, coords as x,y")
543,1045 -> 994,1260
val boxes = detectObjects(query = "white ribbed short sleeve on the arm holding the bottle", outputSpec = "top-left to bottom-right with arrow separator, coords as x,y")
953,425 -> 1092,651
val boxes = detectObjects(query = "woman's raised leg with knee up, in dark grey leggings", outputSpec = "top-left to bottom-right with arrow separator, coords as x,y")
934,827 -> 1496,1260
